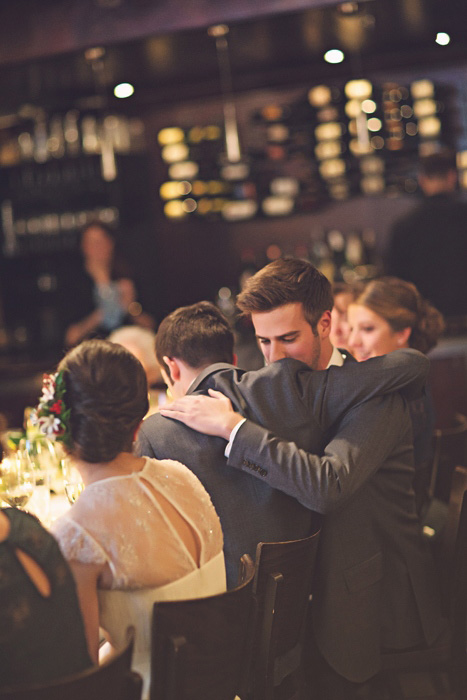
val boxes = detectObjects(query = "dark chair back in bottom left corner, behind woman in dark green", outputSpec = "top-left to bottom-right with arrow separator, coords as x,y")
0,628 -> 142,700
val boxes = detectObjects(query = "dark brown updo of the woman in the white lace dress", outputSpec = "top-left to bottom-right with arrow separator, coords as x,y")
58,340 -> 149,463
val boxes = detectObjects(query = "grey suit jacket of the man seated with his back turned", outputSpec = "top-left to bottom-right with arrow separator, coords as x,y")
137,351 -> 428,586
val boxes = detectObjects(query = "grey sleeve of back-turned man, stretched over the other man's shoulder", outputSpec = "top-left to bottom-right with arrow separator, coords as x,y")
306,348 -> 430,430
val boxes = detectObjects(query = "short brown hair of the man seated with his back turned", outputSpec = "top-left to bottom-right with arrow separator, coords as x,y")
156,301 -> 234,373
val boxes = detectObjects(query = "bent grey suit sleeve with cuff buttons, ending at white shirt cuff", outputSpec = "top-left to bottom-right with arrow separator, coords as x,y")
228,394 -> 410,513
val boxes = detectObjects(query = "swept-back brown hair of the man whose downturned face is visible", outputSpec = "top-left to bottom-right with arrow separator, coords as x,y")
237,258 -> 333,330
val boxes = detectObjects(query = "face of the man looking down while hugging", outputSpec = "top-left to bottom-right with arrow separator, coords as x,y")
251,302 -> 330,369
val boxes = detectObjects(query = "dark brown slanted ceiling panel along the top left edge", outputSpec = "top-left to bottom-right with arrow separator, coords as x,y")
0,0 -> 336,64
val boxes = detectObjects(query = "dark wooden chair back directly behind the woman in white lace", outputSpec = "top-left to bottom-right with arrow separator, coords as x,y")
150,559 -> 256,700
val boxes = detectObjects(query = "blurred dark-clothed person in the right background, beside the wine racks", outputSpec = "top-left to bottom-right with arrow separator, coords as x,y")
383,149 -> 467,332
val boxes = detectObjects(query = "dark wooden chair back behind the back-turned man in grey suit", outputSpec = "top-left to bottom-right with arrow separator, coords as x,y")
250,519 -> 321,700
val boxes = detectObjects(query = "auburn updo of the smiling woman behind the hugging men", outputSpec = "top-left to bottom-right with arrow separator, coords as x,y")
355,277 -> 444,353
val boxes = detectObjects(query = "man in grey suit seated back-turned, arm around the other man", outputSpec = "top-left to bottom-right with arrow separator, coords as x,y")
137,302 -> 427,587
